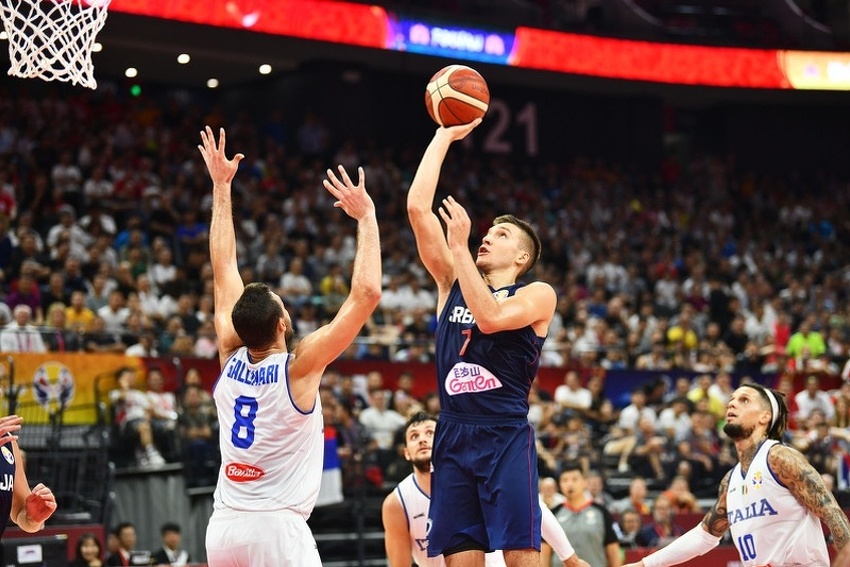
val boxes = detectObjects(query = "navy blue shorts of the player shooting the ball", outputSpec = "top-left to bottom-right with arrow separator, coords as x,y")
428,415 -> 541,557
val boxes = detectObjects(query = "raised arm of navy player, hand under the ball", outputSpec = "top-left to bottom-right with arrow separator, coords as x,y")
407,118 -> 481,298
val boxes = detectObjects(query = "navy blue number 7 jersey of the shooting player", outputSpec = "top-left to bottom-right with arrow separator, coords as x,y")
436,281 -> 545,422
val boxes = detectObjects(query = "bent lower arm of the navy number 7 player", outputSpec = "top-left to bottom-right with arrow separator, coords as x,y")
439,197 -> 558,335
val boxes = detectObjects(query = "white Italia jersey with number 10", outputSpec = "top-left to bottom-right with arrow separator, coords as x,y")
726,440 -> 829,567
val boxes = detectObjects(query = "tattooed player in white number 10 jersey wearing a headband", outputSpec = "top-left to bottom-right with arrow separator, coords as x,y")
626,384 -> 850,567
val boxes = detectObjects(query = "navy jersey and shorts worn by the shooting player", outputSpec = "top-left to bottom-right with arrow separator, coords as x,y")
428,281 -> 545,557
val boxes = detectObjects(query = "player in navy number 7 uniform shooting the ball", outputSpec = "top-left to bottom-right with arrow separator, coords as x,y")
407,119 -> 556,567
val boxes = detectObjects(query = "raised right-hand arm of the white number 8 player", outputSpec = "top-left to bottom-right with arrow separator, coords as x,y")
290,166 -> 381,388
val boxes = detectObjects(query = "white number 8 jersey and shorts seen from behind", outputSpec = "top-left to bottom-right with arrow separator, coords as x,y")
206,347 -> 324,567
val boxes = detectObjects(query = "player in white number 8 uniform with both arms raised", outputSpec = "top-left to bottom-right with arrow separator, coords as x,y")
199,127 -> 381,567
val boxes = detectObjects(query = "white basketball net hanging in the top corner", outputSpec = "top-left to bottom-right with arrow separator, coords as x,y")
0,0 -> 110,89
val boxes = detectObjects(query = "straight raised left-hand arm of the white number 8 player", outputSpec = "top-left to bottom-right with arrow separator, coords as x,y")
198,126 -> 245,364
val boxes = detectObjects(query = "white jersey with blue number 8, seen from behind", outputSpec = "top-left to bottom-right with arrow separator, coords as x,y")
213,347 -> 324,519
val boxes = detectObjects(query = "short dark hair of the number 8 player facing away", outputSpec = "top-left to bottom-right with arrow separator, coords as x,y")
230,282 -> 283,348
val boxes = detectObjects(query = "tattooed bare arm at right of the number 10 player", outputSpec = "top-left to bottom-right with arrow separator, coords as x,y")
767,445 -> 850,551
